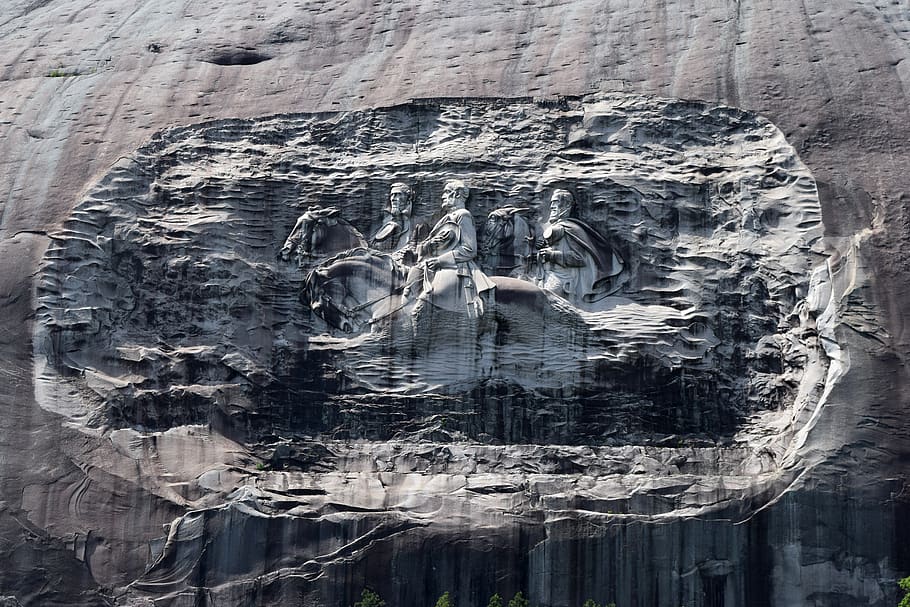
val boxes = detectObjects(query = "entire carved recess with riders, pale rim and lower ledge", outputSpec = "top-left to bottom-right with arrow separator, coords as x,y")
28,96 -> 846,594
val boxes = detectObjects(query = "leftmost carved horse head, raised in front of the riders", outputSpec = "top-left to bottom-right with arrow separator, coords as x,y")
279,207 -> 367,266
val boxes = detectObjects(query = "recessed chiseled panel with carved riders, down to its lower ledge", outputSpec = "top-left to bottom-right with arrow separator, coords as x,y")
33,97 -> 822,442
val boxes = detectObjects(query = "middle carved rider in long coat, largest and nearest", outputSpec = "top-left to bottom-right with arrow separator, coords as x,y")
404,180 -> 495,317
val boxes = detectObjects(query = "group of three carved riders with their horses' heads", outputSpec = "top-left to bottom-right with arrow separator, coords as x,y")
292,180 -> 623,332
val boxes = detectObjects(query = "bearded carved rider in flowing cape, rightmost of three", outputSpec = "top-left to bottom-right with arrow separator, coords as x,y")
537,190 -> 623,304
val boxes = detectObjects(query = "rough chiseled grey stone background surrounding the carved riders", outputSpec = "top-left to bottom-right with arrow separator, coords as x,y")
36,95 -> 832,444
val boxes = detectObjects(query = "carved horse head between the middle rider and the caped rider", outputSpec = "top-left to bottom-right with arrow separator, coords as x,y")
480,206 -> 539,279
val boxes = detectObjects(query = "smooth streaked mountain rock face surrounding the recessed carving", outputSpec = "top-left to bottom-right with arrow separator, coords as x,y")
0,0 -> 910,605
